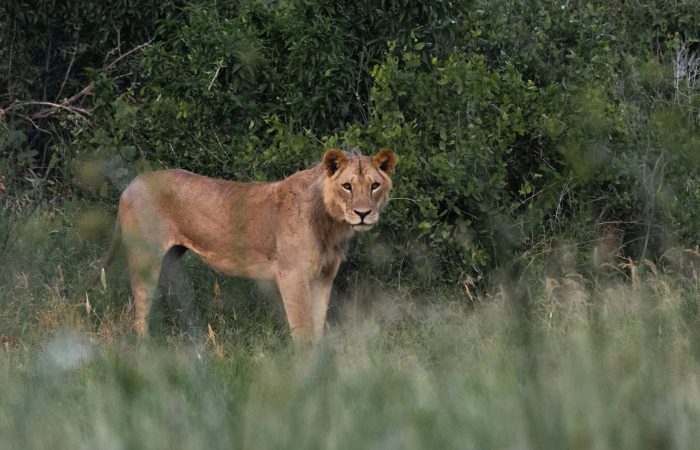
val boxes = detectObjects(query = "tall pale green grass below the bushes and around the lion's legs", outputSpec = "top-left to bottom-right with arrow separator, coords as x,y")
0,205 -> 700,449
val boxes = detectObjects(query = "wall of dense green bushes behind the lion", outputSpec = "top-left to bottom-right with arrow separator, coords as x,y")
0,0 -> 700,282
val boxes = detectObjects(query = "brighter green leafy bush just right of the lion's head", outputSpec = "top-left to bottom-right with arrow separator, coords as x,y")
366,53 -> 542,269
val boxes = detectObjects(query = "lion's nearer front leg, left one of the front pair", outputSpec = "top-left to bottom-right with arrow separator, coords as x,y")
277,273 -> 313,341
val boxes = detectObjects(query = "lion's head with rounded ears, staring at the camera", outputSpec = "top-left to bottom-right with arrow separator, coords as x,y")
323,148 -> 396,231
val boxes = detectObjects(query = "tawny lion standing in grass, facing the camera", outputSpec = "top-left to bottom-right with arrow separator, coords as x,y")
100,148 -> 396,341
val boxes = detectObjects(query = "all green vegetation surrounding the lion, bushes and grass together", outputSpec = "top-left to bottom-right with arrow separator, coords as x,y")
0,0 -> 700,449
